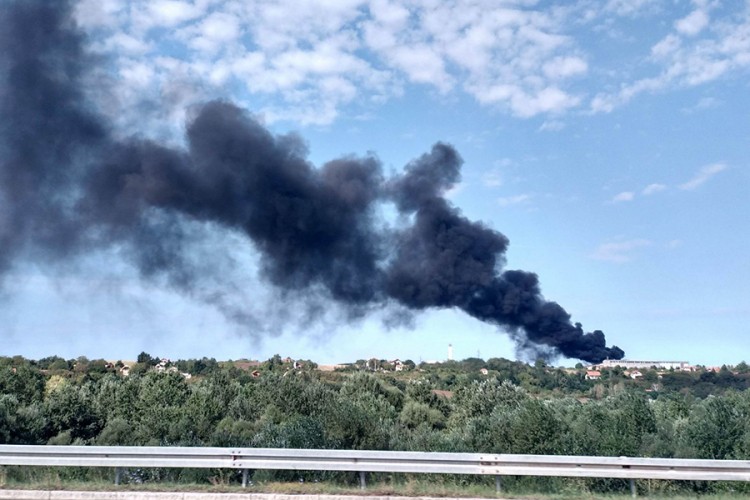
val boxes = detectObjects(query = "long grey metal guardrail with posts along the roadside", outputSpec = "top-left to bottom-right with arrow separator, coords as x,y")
0,445 -> 750,496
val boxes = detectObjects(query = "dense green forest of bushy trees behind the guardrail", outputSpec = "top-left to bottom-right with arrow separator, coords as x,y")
0,353 -> 750,494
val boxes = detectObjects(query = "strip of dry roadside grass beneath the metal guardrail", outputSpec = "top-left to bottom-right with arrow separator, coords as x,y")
0,466 -> 750,500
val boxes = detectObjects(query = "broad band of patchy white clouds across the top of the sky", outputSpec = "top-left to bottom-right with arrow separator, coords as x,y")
76,0 -> 750,130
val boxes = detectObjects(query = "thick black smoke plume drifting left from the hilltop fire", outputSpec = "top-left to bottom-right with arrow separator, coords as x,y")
0,0 -> 623,361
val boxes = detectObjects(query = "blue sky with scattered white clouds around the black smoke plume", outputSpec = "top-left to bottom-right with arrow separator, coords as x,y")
0,0 -> 750,365
